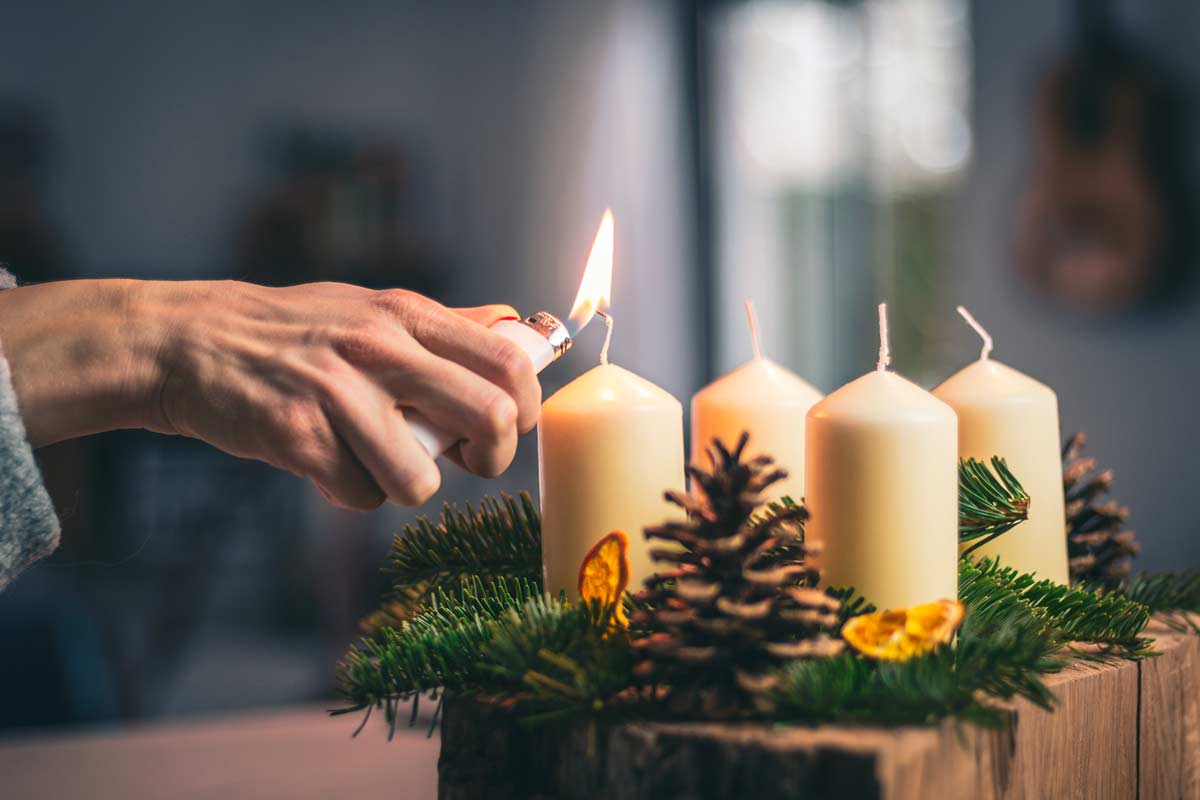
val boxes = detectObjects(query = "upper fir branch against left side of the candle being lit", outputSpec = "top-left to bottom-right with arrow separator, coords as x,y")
381,492 -> 541,631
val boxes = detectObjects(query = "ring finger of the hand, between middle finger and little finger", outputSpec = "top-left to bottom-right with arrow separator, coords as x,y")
325,373 -> 442,506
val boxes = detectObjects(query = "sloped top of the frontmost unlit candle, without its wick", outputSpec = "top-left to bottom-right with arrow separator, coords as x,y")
809,371 -> 958,425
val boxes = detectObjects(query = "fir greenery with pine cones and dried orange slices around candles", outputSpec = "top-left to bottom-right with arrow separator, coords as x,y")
334,434 -> 1200,733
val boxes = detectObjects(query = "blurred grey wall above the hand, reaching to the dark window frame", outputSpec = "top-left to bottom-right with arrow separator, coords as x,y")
0,0 -> 703,532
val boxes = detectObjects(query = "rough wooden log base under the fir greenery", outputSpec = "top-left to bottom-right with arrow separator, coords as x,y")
438,628 -> 1200,800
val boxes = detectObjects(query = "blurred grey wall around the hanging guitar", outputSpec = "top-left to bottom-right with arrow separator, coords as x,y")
964,0 -> 1200,570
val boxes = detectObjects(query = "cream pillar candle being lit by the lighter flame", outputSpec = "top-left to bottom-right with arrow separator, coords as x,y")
538,318 -> 684,596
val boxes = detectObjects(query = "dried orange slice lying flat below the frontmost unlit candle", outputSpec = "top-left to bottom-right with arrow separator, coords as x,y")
841,600 -> 964,661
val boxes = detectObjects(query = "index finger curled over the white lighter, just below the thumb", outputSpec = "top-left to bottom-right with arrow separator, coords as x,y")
379,294 -> 541,433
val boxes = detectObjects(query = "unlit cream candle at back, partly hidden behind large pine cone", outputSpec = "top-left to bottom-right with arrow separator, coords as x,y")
691,300 -> 822,501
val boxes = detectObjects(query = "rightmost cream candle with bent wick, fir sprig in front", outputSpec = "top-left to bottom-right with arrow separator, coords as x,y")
934,306 -> 1070,583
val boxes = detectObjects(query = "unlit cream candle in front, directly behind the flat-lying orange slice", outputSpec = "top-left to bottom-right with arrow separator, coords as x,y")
805,305 -> 959,608
